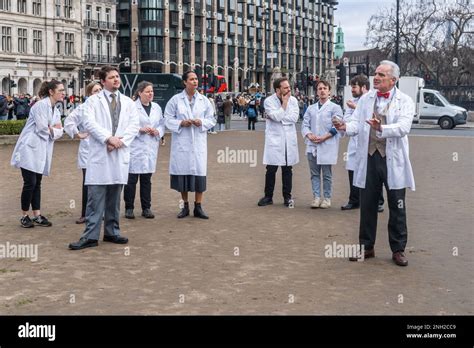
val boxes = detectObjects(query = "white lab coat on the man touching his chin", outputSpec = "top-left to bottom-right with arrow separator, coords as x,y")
263,93 -> 300,166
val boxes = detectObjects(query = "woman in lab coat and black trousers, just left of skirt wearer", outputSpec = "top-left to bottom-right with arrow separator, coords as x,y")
124,81 -> 165,219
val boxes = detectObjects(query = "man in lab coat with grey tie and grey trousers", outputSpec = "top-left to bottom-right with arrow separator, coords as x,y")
69,66 -> 139,250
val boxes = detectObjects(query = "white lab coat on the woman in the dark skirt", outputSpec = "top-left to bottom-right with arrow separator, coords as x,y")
165,90 -> 216,176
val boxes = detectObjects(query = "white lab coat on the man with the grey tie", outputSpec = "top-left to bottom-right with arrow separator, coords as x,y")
84,91 -> 140,185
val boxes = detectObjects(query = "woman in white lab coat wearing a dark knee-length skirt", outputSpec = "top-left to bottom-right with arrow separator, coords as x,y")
165,71 -> 216,219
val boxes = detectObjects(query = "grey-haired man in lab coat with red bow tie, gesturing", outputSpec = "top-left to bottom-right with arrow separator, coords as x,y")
335,60 -> 415,266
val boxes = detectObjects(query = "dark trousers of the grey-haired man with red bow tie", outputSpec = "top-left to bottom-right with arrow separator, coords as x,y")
359,151 -> 408,252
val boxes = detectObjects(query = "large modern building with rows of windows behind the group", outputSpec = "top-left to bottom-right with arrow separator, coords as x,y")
117,0 -> 337,91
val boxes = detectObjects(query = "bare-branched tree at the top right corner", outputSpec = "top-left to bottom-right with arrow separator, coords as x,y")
366,0 -> 474,84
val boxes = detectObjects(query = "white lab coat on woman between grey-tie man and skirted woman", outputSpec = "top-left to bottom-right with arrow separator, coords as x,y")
130,99 -> 165,174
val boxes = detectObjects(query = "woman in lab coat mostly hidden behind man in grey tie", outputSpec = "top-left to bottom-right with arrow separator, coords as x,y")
64,82 -> 102,224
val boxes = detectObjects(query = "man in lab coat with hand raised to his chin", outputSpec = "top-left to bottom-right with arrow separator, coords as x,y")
258,77 -> 299,207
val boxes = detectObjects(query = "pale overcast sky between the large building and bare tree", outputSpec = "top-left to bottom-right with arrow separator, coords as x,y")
334,0 -> 396,51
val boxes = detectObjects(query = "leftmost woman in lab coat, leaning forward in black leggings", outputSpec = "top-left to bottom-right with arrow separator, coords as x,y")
11,80 -> 65,228
